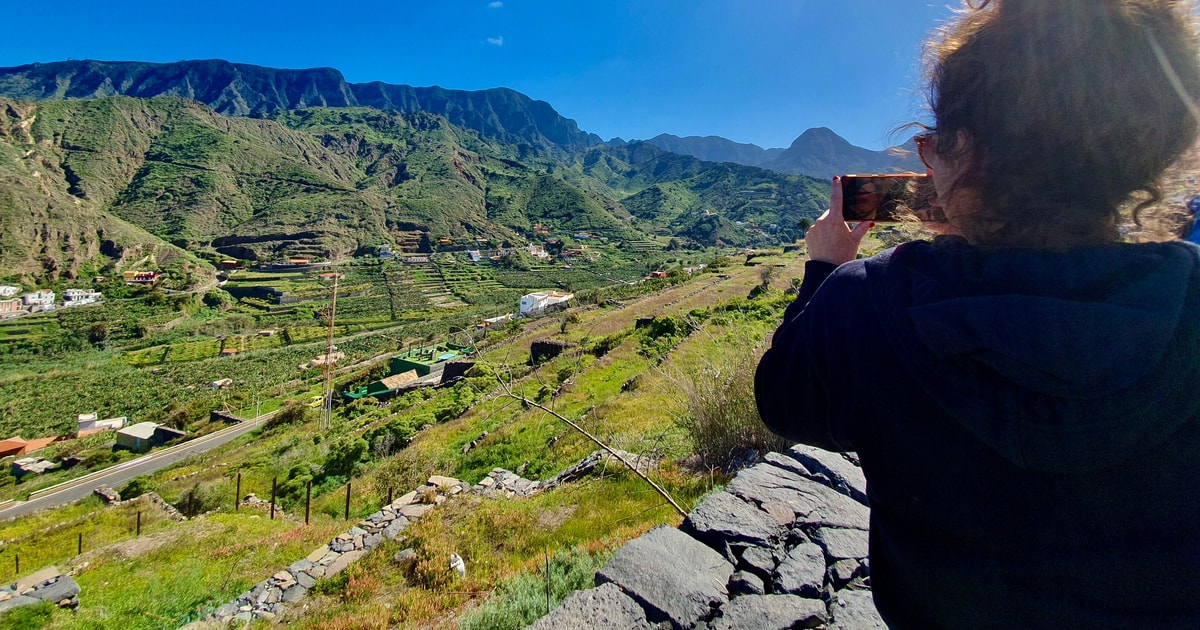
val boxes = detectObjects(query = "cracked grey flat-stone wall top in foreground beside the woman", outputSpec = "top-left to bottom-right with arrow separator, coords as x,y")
530,446 -> 884,630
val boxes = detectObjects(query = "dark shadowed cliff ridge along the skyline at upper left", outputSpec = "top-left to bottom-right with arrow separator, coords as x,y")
0,59 -> 601,149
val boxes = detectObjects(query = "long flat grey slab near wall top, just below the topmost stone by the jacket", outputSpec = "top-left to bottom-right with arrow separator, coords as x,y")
725,463 -> 870,530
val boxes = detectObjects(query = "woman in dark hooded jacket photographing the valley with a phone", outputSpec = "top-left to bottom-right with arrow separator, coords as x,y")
756,0 -> 1200,629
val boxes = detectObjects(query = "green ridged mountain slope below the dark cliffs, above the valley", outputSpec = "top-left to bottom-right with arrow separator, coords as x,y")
0,96 -> 824,280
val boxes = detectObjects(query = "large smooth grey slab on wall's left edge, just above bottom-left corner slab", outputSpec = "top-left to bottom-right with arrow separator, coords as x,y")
596,526 -> 733,628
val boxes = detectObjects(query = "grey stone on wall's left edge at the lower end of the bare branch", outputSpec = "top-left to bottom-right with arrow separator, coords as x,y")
679,492 -> 784,550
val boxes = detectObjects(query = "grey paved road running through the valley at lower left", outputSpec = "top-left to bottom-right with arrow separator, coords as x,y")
0,412 -> 278,520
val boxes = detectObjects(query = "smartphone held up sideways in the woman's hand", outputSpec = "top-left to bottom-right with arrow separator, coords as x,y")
841,173 -> 946,222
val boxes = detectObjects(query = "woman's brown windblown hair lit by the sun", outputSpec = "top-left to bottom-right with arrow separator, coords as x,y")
928,0 -> 1200,248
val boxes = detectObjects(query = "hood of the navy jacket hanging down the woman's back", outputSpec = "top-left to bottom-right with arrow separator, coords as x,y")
865,239 -> 1200,473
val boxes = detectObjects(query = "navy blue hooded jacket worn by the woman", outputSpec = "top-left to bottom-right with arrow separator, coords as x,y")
755,239 -> 1200,629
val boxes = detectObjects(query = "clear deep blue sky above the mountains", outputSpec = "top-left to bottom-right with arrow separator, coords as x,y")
0,0 -> 952,149
